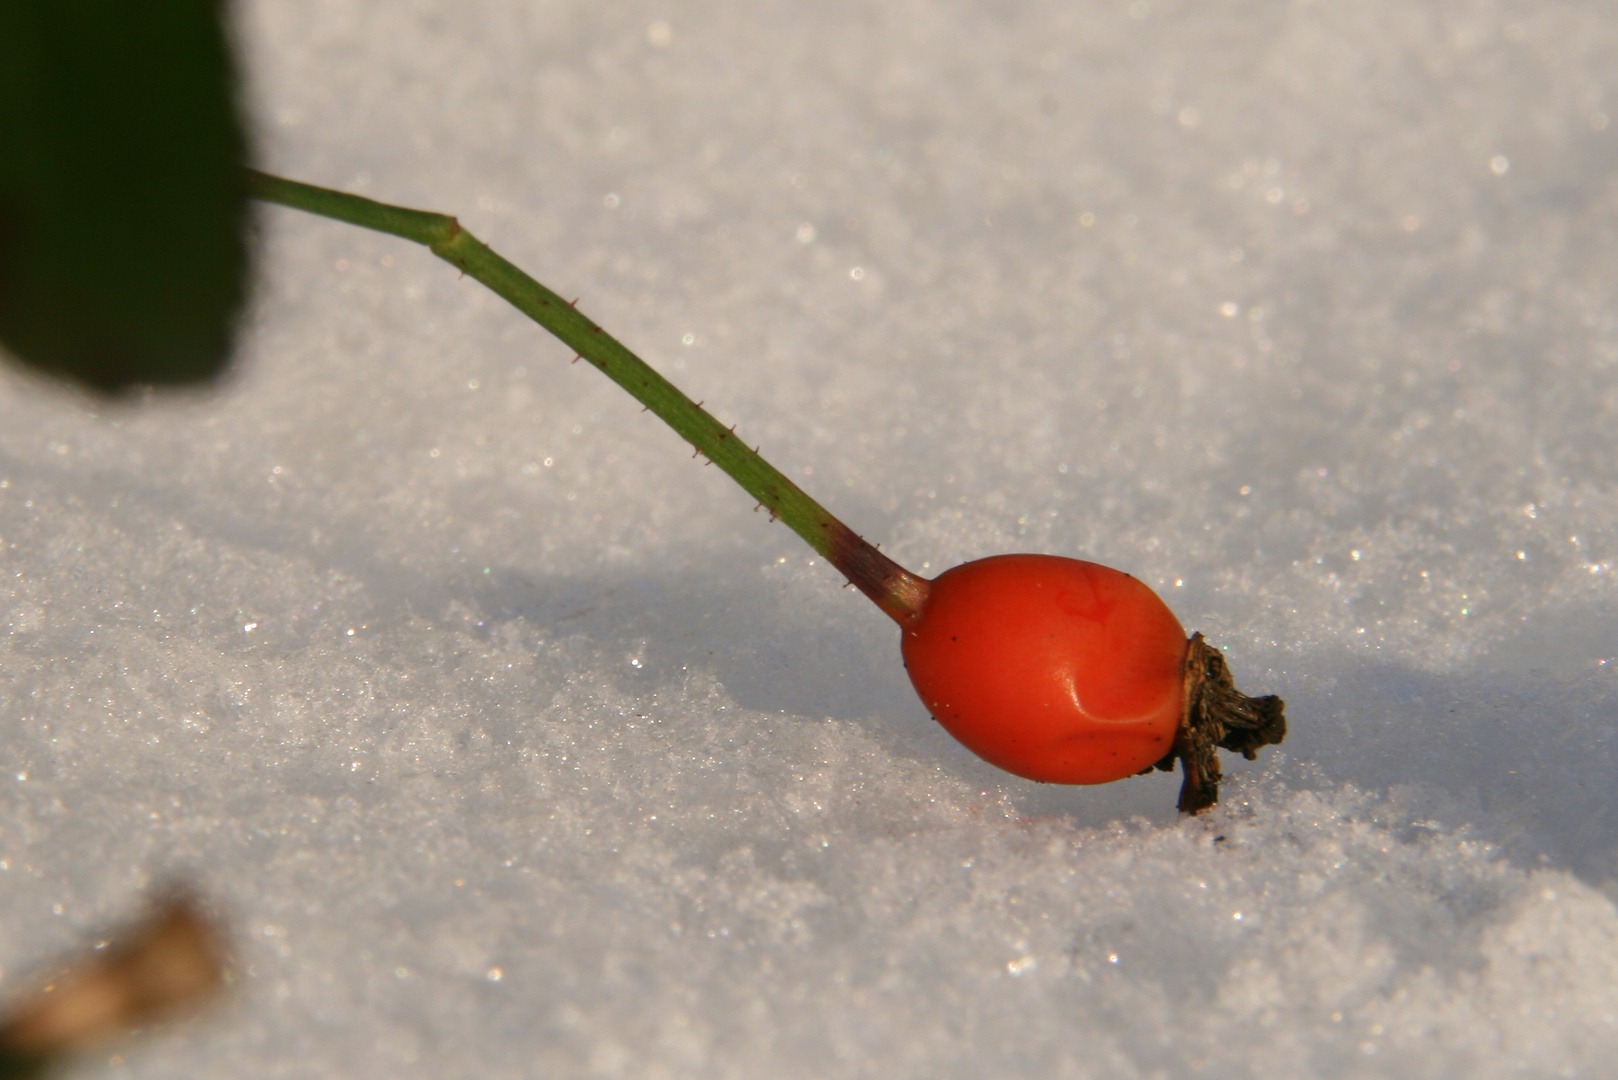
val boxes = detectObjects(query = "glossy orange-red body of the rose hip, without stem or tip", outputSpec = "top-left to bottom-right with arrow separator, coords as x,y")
901,555 -> 1186,784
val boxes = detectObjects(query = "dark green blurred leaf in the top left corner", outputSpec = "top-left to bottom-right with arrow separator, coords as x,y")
0,0 -> 246,390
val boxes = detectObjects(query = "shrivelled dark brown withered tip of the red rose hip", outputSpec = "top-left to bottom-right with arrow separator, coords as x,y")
1147,633 -> 1286,814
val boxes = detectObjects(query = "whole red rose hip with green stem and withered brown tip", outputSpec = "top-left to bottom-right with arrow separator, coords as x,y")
246,170 -> 1286,813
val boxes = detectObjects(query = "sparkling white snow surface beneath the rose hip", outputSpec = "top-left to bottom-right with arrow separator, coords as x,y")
0,0 -> 1618,1080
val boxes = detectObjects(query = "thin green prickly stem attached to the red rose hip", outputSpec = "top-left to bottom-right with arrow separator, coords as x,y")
237,170 -> 929,625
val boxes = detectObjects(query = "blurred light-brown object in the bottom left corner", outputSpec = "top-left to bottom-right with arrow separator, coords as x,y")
0,892 -> 227,1062
